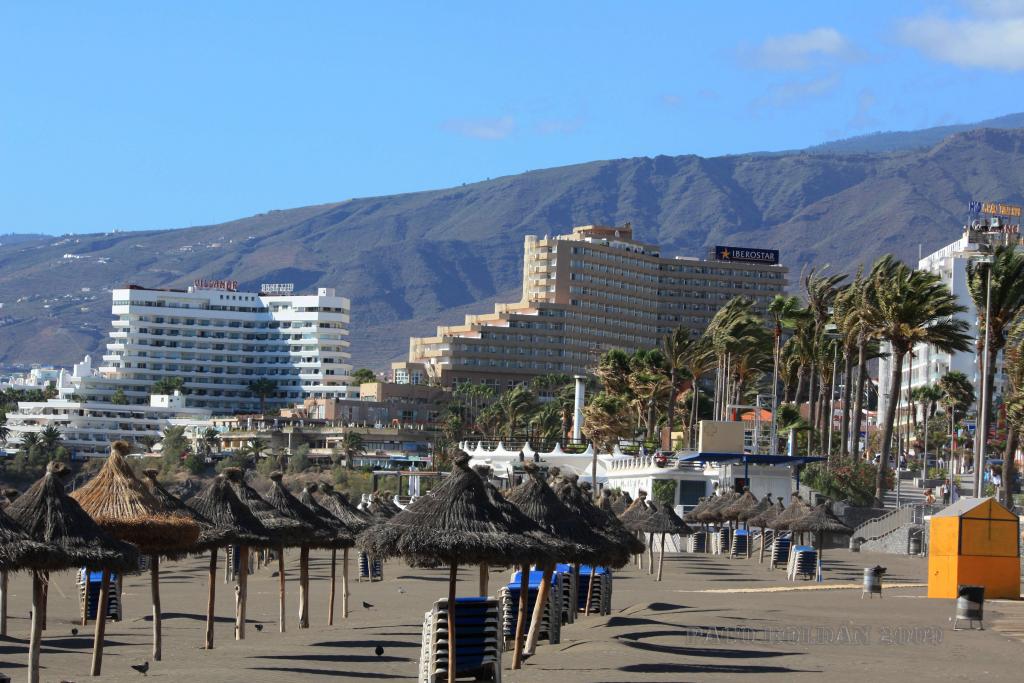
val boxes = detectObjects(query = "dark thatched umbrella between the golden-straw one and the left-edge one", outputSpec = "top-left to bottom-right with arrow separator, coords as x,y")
7,462 -> 138,683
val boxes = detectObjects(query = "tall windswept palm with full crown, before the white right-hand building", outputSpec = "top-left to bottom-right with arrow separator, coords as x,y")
865,256 -> 971,507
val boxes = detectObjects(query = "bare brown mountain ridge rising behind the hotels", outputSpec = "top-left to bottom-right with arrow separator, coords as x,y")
0,122 -> 1024,368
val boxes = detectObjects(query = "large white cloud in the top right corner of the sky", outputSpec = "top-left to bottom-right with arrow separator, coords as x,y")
899,5 -> 1024,71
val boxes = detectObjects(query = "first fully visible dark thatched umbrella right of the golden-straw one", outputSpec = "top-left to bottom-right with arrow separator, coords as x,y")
187,474 -> 270,650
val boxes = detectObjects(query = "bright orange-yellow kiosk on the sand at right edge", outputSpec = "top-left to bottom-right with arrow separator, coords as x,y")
928,498 -> 1021,600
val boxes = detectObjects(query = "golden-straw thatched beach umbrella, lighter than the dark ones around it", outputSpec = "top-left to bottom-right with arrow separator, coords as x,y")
71,441 -> 200,676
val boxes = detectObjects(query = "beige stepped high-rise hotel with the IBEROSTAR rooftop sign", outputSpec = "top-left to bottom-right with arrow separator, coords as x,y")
403,223 -> 788,389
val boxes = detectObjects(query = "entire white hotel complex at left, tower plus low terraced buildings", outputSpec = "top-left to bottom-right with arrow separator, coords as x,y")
7,281 -> 351,457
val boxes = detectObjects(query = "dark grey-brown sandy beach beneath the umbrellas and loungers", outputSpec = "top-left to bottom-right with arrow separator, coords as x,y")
0,550 -> 1024,683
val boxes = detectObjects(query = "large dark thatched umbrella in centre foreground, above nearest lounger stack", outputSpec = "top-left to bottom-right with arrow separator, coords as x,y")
357,454 -> 543,683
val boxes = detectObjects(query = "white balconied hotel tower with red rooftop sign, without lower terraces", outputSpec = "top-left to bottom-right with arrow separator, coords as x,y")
72,281 -> 351,415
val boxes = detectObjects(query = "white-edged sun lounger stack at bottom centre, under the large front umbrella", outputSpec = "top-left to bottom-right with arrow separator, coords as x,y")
419,597 -> 502,683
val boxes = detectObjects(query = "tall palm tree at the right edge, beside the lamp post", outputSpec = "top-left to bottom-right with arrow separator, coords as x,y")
967,246 -> 1024,500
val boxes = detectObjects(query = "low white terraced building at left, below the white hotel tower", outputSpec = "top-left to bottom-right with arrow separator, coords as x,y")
7,394 -> 212,458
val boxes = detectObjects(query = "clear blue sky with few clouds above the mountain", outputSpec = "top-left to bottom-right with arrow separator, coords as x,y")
0,0 -> 1024,233
